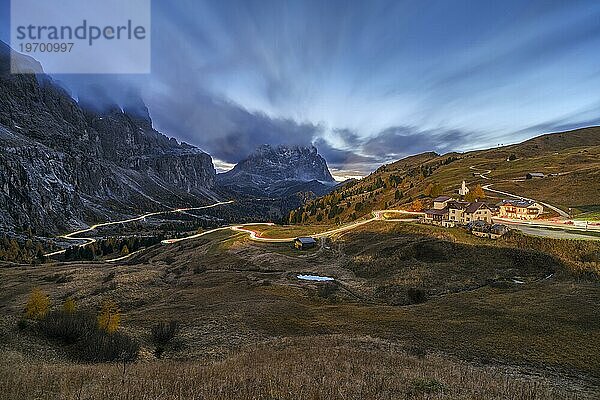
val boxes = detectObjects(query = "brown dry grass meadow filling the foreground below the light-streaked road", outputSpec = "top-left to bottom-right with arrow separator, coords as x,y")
0,222 -> 600,399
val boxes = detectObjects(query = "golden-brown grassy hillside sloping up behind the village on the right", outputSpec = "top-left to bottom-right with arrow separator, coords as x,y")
289,127 -> 600,224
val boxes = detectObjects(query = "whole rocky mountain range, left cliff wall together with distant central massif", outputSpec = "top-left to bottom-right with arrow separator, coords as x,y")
0,42 -> 335,234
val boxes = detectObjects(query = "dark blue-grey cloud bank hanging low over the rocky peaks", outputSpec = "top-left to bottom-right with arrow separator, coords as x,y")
56,76 -> 322,163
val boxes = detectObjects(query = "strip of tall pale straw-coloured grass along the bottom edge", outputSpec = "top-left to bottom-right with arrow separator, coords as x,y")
0,337 -> 582,400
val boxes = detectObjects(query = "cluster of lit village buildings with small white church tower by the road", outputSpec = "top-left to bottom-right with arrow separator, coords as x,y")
422,181 -> 544,239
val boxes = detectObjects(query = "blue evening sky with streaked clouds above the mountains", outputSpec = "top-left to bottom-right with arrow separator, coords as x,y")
0,0 -> 600,178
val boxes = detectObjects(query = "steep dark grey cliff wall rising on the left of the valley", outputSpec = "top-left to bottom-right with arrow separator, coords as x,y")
0,42 -> 216,233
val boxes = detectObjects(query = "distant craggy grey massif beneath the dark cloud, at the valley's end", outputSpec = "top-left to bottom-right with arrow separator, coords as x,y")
217,145 -> 336,197
